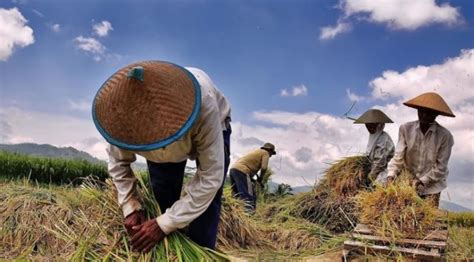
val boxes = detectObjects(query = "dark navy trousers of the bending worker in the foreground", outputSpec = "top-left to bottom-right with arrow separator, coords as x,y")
148,126 -> 232,249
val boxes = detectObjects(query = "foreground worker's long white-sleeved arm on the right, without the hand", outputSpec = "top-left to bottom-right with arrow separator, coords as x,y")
157,101 -> 224,234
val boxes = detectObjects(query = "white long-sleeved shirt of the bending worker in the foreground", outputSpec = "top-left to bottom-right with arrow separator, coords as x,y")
107,68 -> 230,234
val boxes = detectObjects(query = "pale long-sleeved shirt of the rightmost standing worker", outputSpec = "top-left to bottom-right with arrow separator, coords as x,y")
388,121 -> 454,195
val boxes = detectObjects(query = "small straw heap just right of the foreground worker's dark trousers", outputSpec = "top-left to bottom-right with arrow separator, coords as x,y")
217,187 -> 267,249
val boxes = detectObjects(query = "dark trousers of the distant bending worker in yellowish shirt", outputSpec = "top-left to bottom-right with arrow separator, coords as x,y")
229,168 -> 257,212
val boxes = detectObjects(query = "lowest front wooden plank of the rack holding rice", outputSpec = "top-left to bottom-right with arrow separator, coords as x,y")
344,240 -> 441,261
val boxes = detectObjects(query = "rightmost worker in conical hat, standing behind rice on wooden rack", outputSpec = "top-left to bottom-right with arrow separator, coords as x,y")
388,92 -> 455,207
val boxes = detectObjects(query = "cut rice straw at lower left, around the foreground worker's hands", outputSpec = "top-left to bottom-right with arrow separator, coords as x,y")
0,176 -> 227,261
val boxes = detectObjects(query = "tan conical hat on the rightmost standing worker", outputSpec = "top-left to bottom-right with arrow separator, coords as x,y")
403,92 -> 456,117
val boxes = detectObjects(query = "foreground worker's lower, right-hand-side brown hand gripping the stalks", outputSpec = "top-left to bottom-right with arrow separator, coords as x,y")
130,219 -> 166,253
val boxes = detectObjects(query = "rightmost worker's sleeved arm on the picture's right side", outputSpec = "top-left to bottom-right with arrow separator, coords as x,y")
420,134 -> 454,187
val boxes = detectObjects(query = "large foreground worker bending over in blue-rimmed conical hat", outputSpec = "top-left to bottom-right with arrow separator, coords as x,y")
92,61 -> 231,252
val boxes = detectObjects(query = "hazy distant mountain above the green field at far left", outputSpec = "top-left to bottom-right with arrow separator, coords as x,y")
0,143 -> 105,164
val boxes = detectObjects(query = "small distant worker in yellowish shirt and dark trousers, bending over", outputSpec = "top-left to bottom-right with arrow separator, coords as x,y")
230,143 -> 276,212
